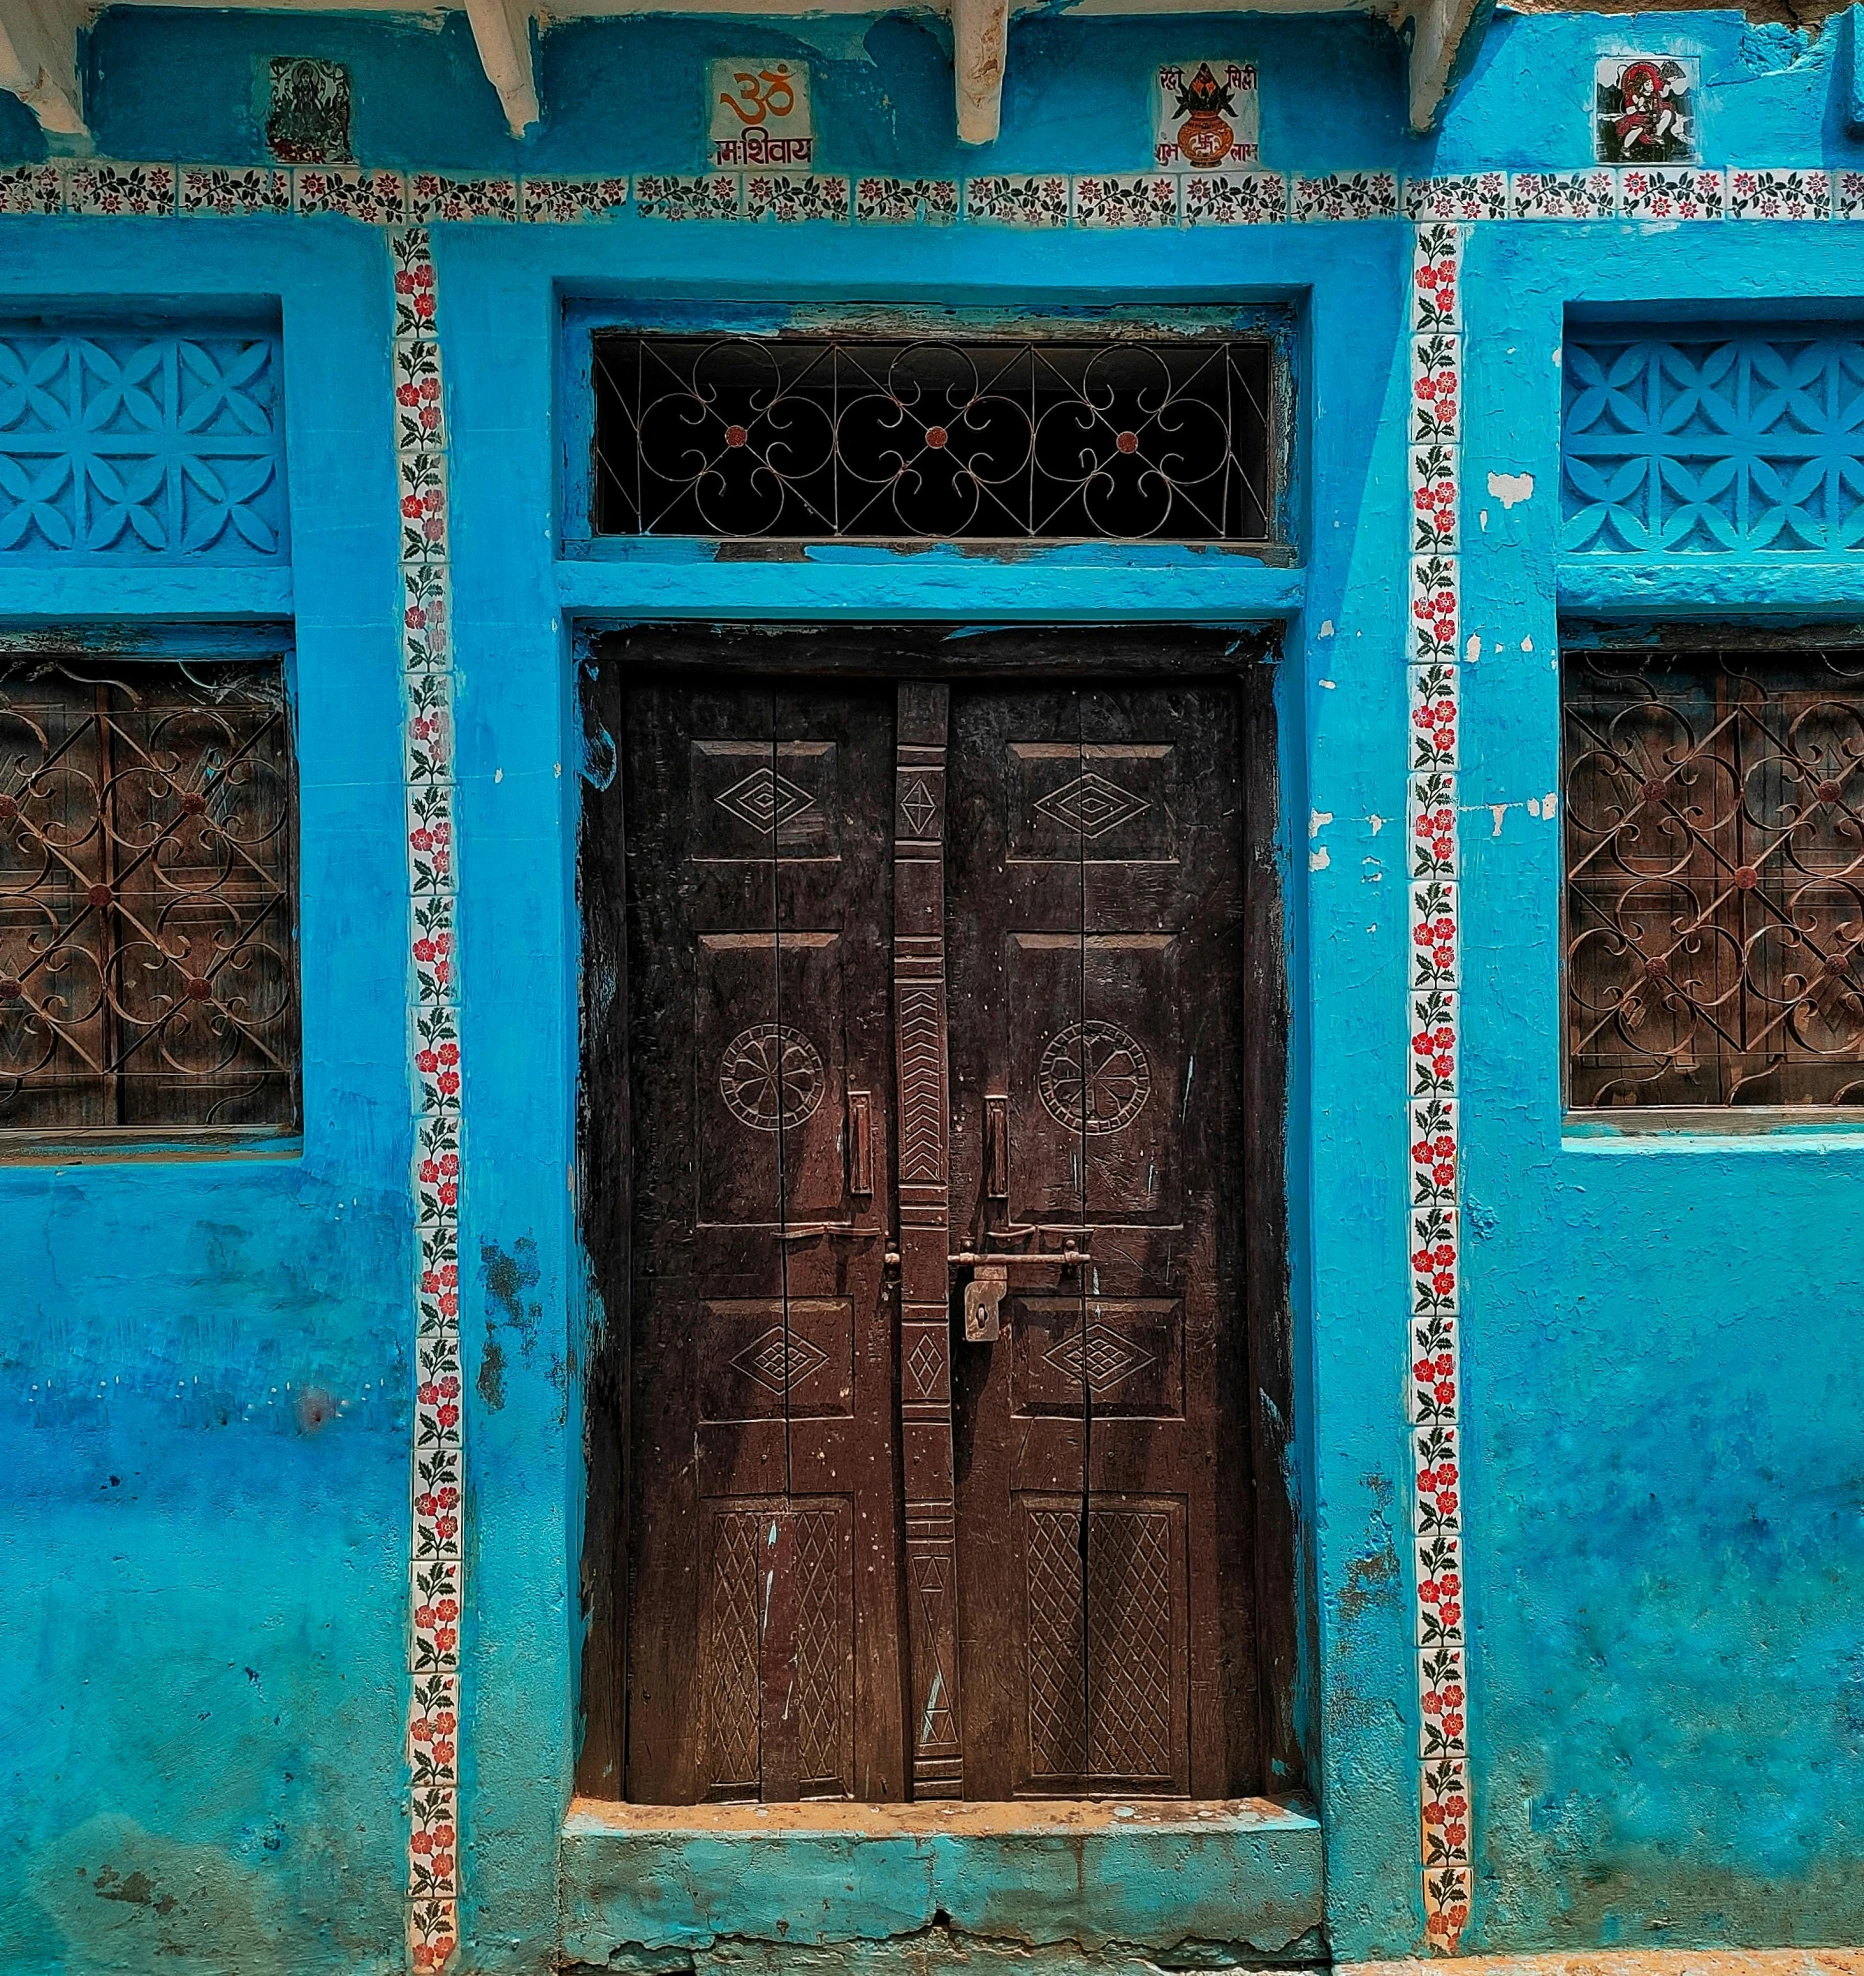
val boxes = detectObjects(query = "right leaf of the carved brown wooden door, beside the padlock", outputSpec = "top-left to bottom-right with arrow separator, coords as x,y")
947,686 -> 1257,1798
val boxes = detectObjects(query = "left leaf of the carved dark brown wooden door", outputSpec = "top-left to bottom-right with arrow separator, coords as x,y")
623,684 -> 905,1804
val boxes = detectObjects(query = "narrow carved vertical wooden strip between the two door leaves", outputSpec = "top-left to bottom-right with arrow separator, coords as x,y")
893,684 -> 965,1798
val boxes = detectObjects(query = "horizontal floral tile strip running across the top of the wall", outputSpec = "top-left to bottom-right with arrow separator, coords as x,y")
0,158 -> 1864,229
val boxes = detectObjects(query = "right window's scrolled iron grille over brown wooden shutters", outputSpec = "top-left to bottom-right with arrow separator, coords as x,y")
1562,650 -> 1864,1109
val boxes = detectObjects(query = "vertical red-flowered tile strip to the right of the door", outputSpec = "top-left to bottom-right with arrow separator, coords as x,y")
1405,220 -> 1484,1954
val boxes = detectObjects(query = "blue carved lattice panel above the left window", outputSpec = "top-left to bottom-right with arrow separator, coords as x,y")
0,324 -> 289,563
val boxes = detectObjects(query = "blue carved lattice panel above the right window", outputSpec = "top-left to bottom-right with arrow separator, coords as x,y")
1560,326 -> 1864,555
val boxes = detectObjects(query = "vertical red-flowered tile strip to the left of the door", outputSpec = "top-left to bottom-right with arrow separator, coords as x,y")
389,224 -> 464,1970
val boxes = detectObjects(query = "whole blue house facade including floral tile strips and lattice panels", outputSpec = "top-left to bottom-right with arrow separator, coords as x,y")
0,8 -> 1864,1976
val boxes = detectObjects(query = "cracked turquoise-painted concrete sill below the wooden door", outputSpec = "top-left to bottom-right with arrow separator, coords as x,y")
563,1798 -> 1322,1968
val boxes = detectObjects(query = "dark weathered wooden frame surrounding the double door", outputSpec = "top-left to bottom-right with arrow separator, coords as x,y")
575,618 -> 1309,1818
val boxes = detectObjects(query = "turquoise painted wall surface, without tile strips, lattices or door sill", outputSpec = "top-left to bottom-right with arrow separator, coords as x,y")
0,10 -> 1864,1976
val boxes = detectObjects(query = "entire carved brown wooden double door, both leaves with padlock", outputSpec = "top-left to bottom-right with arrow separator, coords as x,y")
620,676 -> 1259,1804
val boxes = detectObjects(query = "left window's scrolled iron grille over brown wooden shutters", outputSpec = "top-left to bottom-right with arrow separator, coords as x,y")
0,658 -> 298,1130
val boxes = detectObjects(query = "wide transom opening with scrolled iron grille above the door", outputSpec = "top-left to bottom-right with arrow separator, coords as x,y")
593,332 -> 1275,541
